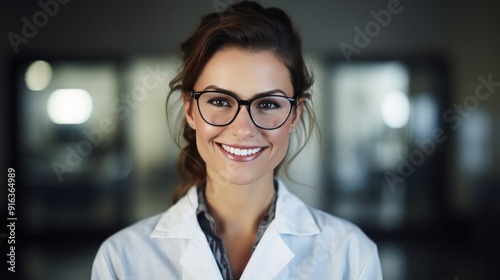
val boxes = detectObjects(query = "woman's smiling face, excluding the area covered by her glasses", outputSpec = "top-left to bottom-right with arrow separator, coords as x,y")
184,48 -> 301,188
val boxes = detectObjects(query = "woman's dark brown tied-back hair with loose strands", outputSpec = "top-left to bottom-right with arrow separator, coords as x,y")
167,1 -> 315,203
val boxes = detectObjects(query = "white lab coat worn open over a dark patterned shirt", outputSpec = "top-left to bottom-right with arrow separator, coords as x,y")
92,182 -> 382,280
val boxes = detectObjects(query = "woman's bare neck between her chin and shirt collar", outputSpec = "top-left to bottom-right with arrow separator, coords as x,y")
205,174 -> 275,236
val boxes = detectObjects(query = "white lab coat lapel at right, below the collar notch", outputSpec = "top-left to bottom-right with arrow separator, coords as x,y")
241,222 -> 295,280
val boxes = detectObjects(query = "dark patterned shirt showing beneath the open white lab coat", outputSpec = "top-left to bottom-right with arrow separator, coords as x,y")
196,180 -> 278,280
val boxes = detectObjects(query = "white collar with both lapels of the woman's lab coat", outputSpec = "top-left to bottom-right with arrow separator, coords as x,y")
151,180 -> 320,280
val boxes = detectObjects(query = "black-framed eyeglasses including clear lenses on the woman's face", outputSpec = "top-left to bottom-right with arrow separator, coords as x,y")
191,90 -> 297,130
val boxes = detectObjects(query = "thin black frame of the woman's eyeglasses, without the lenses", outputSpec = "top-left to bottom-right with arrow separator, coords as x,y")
190,89 -> 297,130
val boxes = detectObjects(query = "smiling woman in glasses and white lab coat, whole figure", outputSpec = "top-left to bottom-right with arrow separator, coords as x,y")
92,2 -> 382,280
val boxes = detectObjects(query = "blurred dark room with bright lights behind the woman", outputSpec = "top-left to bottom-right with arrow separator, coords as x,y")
0,0 -> 500,280
